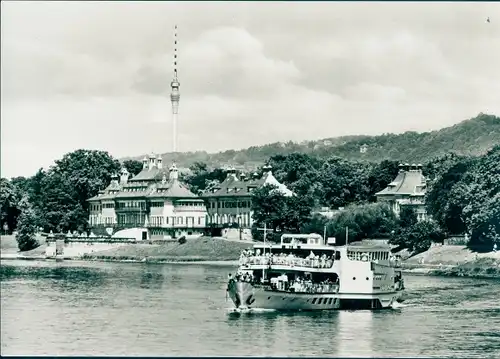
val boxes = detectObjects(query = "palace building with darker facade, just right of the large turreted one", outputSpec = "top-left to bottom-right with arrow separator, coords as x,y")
202,166 -> 293,229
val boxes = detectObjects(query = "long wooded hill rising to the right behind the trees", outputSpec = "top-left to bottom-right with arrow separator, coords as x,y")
124,113 -> 500,170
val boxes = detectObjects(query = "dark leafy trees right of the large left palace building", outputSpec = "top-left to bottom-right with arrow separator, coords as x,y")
185,145 -> 500,252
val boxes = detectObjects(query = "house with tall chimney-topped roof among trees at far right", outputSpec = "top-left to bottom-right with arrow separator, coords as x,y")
375,163 -> 427,221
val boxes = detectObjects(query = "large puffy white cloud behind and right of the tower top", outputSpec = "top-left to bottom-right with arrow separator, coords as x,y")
134,27 -> 300,98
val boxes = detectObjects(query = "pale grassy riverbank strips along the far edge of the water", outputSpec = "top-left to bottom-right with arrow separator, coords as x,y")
1,236 -> 500,278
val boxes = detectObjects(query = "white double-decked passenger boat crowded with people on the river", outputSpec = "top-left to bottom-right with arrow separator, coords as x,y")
226,234 -> 404,311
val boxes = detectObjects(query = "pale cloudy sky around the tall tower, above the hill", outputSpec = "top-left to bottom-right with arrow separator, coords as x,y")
1,1 -> 500,177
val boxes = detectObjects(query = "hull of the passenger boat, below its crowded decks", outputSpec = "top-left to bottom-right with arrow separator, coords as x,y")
227,281 -> 401,311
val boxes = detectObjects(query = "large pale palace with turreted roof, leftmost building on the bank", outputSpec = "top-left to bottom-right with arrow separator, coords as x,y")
88,154 -> 207,239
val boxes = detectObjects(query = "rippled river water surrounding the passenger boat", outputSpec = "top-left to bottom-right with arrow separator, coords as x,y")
1,261 -> 500,358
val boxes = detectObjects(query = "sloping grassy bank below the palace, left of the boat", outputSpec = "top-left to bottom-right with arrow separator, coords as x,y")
85,237 -> 252,262
